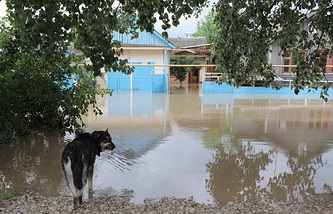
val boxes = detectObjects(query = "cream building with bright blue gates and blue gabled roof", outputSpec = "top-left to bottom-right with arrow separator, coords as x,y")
107,31 -> 176,92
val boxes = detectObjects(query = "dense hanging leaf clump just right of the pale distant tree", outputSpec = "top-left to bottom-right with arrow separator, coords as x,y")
213,1 -> 279,88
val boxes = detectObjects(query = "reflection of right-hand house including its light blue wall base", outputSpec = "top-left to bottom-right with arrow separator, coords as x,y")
201,95 -> 333,133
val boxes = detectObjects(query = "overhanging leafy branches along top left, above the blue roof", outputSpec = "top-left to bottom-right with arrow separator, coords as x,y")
6,0 -> 205,75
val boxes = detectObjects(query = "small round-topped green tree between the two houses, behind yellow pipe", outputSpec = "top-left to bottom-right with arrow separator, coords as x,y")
170,56 -> 202,85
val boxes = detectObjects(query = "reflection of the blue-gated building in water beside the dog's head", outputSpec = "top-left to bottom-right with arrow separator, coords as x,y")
84,90 -> 170,158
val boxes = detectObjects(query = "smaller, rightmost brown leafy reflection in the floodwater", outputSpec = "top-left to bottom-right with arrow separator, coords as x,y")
267,150 -> 324,201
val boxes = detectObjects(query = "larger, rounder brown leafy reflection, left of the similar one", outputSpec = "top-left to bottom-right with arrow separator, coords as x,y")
206,137 -> 273,206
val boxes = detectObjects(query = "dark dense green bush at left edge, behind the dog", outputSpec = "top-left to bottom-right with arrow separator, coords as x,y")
0,17 -> 107,138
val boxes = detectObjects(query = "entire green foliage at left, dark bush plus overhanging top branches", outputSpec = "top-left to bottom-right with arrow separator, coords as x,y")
0,0 -> 206,138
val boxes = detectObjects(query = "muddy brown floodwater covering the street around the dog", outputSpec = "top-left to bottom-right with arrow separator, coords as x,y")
0,86 -> 333,204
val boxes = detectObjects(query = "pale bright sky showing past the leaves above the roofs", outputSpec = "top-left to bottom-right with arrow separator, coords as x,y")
0,0 -> 216,37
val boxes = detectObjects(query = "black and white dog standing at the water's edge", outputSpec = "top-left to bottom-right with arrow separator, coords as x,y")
61,129 -> 116,209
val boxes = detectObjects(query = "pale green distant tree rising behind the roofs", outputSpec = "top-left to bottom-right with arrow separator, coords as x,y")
194,10 -> 216,43
